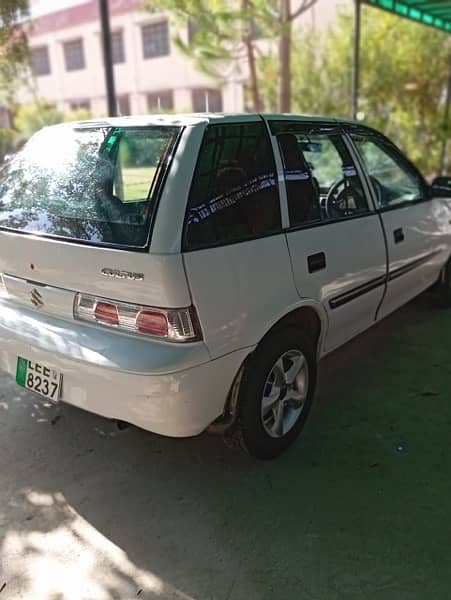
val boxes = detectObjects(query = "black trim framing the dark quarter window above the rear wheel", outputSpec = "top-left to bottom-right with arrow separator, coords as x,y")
180,115 -> 285,254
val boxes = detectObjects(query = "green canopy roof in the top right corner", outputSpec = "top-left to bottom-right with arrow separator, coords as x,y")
362,0 -> 451,33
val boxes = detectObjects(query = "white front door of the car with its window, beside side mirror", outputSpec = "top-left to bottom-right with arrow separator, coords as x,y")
351,128 -> 449,318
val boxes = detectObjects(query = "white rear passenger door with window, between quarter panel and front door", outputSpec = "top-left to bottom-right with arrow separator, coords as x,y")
270,120 -> 387,352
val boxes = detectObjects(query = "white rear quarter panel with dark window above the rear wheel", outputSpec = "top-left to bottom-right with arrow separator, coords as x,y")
182,116 -> 299,358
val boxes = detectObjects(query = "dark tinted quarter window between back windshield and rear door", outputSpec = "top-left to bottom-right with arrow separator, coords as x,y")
184,123 -> 281,250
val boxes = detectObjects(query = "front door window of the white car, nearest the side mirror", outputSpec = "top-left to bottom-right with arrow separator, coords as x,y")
352,135 -> 425,208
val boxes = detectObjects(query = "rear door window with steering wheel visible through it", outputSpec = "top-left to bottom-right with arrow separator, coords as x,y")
277,128 -> 369,226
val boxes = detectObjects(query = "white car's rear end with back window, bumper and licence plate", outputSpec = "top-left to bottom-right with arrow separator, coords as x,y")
0,119 -> 242,436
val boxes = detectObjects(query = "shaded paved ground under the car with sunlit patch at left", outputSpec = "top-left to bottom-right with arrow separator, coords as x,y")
0,298 -> 451,600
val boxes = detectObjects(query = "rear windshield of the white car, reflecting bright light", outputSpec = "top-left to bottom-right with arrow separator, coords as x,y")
0,125 -> 180,248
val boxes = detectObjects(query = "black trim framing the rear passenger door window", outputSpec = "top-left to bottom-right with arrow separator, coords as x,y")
267,119 -> 377,233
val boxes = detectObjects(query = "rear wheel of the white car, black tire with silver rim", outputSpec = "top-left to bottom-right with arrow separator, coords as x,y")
226,326 -> 317,460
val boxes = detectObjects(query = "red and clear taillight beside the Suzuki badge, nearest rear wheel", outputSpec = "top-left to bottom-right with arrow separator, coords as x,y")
74,294 -> 202,342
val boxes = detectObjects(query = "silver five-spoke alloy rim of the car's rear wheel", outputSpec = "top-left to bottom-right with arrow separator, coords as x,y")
261,349 -> 309,438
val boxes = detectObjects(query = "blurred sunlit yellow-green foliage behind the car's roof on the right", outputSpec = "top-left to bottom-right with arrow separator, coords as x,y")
258,8 -> 451,174
